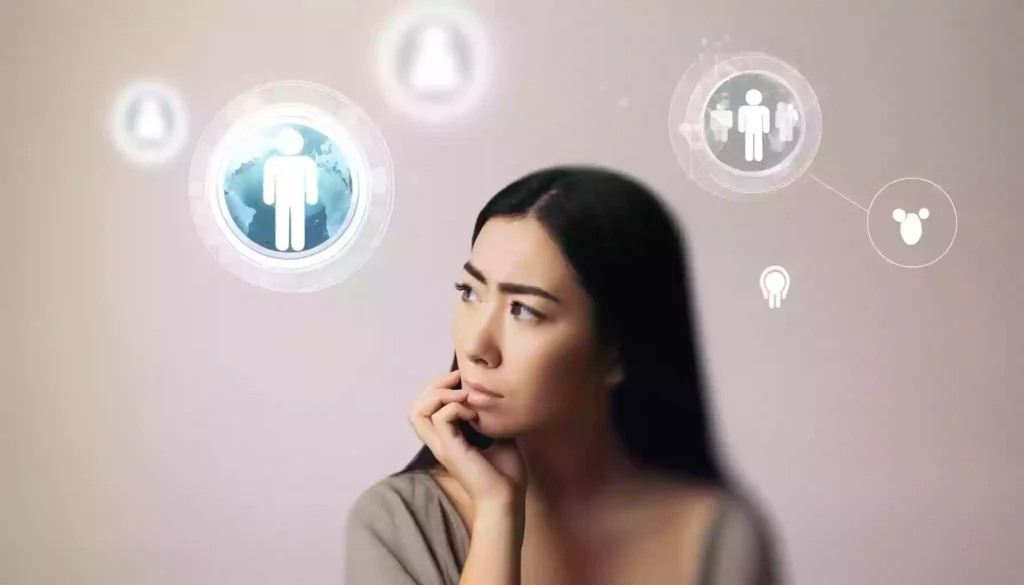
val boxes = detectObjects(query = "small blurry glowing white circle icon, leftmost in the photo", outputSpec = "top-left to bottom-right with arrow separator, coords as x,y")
111,81 -> 188,167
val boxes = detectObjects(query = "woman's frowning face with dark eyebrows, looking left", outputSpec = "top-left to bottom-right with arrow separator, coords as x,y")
454,217 -> 618,438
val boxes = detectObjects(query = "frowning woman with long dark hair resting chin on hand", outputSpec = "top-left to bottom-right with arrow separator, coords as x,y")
345,167 -> 777,585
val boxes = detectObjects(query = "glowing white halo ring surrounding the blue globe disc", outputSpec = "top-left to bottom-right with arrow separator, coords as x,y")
188,81 -> 394,292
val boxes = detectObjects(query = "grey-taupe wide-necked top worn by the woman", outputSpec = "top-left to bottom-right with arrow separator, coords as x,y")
345,471 -> 775,585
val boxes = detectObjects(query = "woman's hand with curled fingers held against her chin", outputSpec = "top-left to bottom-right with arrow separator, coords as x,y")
409,370 -> 526,507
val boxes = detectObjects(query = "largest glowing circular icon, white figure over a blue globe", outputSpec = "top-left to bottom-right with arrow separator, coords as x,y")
189,81 -> 393,292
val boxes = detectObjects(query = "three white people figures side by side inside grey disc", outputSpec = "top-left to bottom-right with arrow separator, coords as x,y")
710,89 -> 800,162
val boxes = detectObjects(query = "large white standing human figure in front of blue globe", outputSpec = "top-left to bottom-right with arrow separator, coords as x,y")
263,128 -> 319,252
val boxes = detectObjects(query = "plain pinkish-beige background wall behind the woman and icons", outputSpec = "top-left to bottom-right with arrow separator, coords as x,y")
0,0 -> 1024,585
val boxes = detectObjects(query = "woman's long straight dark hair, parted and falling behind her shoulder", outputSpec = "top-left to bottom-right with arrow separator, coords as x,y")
398,166 -> 731,487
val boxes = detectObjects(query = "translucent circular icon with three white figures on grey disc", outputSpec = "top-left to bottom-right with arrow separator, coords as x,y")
669,53 -> 821,199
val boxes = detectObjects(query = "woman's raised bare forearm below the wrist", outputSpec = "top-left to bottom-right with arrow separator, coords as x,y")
459,505 -> 525,585
